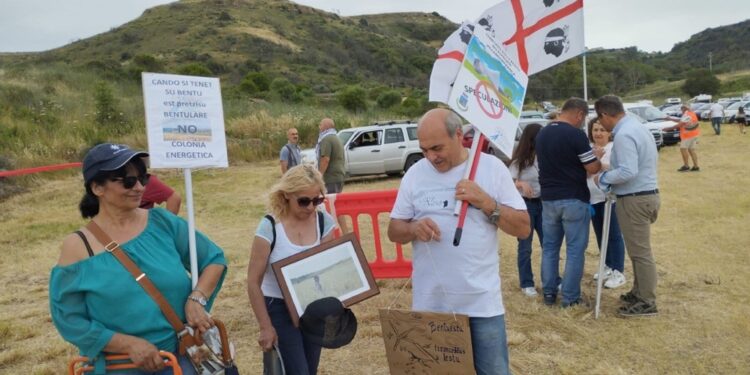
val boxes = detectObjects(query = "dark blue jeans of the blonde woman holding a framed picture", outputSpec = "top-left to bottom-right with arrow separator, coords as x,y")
265,297 -> 322,375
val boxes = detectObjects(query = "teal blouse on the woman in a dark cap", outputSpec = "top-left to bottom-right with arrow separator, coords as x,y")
49,208 -> 226,358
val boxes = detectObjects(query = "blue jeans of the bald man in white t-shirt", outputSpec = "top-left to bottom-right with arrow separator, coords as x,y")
469,315 -> 510,375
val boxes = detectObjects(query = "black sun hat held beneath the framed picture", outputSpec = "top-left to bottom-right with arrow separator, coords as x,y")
299,297 -> 357,349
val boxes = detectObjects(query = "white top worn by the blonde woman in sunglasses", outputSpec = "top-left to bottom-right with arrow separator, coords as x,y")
255,212 -> 336,298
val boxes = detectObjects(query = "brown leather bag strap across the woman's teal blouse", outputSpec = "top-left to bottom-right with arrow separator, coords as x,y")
86,220 -> 191,337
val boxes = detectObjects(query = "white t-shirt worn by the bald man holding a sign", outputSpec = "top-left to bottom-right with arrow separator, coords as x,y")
391,154 -> 526,318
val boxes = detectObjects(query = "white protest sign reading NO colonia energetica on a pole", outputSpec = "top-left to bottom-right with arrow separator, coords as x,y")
141,73 -> 229,168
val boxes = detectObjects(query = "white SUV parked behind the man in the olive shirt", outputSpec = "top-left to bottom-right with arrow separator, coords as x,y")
302,121 -> 423,176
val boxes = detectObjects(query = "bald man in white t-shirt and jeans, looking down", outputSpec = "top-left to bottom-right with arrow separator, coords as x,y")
388,108 -> 531,374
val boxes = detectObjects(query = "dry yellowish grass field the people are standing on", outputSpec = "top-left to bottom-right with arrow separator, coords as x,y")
0,123 -> 750,374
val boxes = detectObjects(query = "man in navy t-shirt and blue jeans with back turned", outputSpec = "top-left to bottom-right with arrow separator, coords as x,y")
536,98 -> 601,307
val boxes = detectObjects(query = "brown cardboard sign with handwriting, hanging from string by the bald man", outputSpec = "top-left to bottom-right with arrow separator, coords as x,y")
380,309 -> 475,375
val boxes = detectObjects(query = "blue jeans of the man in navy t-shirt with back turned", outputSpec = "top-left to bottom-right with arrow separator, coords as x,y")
542,199 -> 591,304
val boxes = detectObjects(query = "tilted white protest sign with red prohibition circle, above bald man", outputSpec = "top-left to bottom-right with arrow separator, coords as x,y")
448,28 -> 529,157
